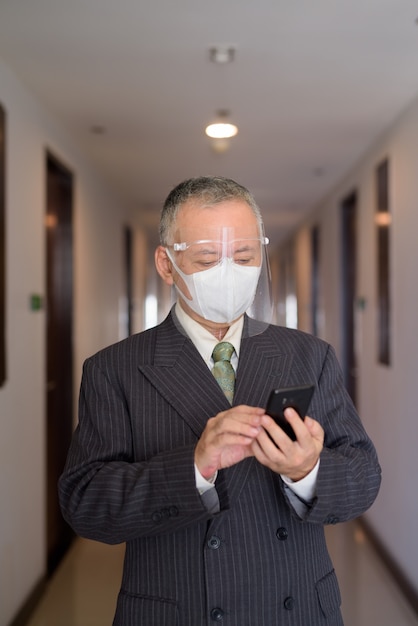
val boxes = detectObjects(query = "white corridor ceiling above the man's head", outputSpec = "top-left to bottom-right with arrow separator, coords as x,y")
0,0 -> 418,241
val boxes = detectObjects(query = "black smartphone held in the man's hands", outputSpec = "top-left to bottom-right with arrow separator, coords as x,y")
266,385 -> 315,441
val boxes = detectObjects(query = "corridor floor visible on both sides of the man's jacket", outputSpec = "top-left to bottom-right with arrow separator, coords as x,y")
21,522 -> 418,626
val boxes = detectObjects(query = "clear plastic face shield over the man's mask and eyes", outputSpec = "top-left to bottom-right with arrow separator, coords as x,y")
166,224 -> 273,333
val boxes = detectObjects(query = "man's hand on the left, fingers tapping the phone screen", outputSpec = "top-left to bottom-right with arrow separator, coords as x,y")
195,405 -> 267,479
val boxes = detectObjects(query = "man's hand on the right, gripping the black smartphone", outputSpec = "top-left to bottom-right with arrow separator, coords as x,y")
251,408 -> 324,481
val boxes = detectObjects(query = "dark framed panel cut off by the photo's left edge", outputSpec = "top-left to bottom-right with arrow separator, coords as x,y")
0,104 -> 6,386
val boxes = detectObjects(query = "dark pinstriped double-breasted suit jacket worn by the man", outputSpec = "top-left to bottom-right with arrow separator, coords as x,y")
59,314 -> 380,626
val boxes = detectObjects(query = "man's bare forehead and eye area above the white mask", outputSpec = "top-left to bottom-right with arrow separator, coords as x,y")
170,200 -> 261,276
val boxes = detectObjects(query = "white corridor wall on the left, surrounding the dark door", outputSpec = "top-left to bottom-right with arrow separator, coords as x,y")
0,61 -> 147,626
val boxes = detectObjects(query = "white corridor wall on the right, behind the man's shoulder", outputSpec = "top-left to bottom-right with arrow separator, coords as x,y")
286,95 -> 418,592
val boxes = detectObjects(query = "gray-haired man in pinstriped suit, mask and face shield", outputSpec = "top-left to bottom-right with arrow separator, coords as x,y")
59,177 -> 380,626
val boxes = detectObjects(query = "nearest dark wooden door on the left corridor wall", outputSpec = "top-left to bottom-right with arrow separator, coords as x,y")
45,154 -> 73,574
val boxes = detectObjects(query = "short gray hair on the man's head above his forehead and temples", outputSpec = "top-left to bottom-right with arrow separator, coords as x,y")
159,176 -> 263,246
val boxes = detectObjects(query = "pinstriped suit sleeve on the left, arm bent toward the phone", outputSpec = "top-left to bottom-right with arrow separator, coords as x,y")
59,359 -> 211,543
